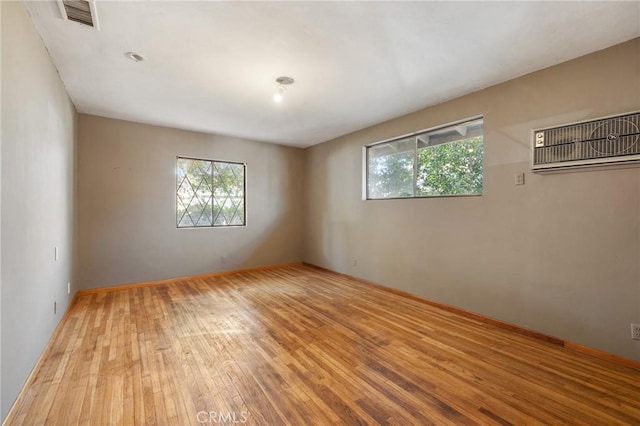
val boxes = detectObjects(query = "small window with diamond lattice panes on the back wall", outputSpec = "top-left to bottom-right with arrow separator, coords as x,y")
176,157 -> 245,228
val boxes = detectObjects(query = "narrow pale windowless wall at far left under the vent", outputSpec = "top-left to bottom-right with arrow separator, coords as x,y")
0,2 -> 76,418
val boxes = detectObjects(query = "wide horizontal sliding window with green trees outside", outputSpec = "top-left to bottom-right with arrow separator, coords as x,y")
366,118 -> 484,200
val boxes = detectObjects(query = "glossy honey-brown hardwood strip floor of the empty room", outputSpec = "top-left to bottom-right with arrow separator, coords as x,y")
7,266 -> 640,425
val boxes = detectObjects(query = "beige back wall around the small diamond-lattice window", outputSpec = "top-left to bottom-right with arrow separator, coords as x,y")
78,114 -> 303,288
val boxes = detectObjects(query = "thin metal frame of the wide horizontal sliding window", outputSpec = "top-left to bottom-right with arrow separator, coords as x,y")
362,115 -> 484,201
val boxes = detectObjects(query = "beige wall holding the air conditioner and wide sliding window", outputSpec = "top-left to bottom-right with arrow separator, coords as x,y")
304,39 -> 640,360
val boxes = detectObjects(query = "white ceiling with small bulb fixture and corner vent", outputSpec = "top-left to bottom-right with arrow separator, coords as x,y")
26,0 -> 640,147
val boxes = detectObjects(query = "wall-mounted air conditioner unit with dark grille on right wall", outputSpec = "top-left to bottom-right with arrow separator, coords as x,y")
531,111 -> 640,172
